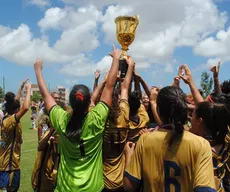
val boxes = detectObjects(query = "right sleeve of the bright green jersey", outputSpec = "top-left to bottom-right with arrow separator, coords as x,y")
88,102 -> 109,132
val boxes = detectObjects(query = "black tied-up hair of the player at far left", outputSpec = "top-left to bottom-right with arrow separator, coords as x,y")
5,92 -> 20,115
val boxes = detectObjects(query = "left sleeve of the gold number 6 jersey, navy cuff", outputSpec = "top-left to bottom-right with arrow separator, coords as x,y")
124,136 -> 143,184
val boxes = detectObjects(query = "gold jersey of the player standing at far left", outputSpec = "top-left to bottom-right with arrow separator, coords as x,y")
0,114 -> 22,171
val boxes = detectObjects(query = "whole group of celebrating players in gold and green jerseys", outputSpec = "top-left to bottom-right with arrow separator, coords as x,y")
0,47 -> 230,192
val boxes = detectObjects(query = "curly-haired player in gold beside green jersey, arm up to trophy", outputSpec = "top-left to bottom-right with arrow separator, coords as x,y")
103,58 -> 134,192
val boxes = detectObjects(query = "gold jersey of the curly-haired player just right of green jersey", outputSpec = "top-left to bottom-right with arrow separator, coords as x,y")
102,100 -> 129,189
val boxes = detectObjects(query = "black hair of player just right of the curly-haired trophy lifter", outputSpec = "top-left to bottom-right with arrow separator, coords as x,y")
129,91 -> 141,116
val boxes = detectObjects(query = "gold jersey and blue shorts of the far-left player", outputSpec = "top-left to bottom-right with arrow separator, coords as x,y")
0,114 -> 22,190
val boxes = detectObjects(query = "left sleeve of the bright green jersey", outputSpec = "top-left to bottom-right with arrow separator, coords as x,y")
49,105 -> 68,132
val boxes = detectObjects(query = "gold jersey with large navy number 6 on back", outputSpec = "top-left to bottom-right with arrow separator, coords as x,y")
125,129 -> 216,192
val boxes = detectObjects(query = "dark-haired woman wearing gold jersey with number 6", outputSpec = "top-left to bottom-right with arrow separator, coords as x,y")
124,86 -> 216,192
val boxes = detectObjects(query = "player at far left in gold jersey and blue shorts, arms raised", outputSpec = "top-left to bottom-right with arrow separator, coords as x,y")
0,80 -> 31,192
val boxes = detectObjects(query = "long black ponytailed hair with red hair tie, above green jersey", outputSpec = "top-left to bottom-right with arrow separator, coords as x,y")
66,84 -> 91,142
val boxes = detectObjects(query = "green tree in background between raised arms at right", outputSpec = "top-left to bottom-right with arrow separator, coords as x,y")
200,71 -> 213,97
